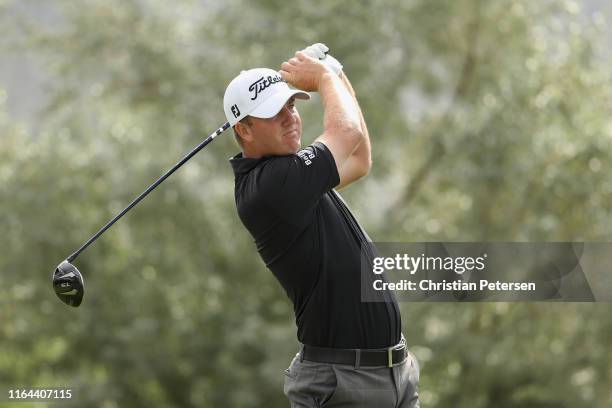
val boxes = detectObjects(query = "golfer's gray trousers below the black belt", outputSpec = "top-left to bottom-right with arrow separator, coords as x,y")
284,351 -> 419,408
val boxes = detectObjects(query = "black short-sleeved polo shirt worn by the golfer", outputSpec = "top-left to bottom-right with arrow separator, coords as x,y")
230,142 -> 401,348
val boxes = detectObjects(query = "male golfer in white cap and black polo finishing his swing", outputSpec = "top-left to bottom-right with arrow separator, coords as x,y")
223,44 -> 419,408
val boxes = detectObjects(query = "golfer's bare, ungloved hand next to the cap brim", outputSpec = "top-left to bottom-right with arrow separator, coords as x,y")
279,51 -> 333,92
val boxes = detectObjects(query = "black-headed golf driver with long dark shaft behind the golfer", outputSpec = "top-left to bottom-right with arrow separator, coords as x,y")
53,122 -> 230,307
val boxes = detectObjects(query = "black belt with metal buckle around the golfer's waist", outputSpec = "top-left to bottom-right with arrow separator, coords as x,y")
300,339 -> 408,368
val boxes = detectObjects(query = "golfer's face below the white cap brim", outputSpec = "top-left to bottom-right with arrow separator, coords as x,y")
243,98 -> 302,157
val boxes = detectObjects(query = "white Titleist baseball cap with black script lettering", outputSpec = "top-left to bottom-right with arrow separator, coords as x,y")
223,68 -> 310,126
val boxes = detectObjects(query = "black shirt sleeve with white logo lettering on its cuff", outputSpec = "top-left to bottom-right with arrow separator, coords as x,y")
262,142 -> 340,223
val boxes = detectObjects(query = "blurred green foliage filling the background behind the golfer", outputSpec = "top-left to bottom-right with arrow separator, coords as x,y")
0,0 -> 612,408
